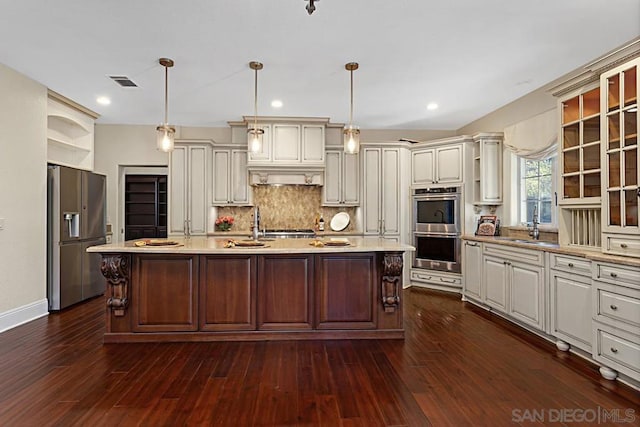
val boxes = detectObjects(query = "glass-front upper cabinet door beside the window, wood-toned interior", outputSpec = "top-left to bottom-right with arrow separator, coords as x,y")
559,85 -> 601,205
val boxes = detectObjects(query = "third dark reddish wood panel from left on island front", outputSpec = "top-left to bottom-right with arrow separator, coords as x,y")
258,255 -> 313,330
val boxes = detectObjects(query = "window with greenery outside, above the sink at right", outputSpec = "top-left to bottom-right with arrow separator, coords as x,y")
519,157 -> 556,225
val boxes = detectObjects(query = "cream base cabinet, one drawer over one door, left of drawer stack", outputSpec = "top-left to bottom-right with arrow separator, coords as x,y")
549,254 -> 592,353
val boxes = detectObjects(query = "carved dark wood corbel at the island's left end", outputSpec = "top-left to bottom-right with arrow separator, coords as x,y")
100,254 -> 131,317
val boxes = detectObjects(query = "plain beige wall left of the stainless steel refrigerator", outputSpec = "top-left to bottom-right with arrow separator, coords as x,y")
0,64 -> 47,318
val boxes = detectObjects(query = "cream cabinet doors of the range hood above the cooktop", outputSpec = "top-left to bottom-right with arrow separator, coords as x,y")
247,123 -> 325,167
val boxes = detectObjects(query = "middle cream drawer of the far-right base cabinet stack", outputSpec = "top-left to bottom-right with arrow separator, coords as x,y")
596,283 -> 640,331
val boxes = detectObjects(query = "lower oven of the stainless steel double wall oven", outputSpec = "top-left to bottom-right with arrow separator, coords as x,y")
413,233 -> 462,273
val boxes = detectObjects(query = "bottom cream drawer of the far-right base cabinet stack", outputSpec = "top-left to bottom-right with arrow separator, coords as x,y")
595,328 -> 640,376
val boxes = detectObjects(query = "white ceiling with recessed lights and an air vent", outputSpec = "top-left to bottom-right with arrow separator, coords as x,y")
0,0 -> 640,130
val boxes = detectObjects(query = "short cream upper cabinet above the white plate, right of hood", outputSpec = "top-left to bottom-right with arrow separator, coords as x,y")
322,149 -> 360,206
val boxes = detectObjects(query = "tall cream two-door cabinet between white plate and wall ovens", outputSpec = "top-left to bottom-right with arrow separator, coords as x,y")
360,147 -> 401,240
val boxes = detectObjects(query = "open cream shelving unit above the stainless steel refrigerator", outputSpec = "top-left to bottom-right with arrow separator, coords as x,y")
47,91 -> 98,170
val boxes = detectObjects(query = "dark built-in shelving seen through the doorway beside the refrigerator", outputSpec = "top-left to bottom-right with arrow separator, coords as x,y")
124,175 -> 167,240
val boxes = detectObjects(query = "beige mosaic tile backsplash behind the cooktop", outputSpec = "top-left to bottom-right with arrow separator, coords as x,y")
218,185 -> 356,232
